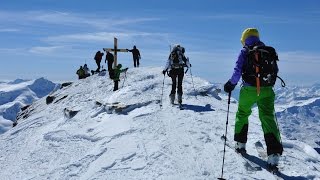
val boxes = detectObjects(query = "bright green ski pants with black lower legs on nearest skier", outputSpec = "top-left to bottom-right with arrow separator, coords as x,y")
234,86 -> 283,155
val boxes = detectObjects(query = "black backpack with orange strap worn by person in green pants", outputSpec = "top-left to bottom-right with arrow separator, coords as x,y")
242,46 -> 285,86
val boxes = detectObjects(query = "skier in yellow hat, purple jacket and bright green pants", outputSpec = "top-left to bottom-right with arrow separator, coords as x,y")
224,28 -> 283,171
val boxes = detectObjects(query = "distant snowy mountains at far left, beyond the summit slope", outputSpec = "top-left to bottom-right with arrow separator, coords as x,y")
0,78 -> 58,134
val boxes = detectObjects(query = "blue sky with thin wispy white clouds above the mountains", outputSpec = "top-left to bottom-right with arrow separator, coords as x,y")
0,0 -> 320,85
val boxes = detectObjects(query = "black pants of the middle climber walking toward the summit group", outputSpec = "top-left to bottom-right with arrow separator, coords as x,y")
169,68 -> 184,96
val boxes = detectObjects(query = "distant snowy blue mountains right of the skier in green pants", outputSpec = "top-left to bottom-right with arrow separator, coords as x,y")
276,84 -> 320,150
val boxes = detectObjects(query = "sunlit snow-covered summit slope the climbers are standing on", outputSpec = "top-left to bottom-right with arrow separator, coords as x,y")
0,67 -> 320,180
